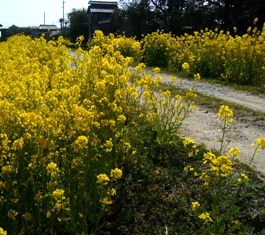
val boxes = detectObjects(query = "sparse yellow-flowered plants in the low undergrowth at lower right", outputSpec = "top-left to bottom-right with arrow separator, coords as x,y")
183,105 -> 265,234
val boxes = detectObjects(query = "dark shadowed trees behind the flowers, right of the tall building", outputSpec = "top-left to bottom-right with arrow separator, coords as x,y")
116,0 -> 265,37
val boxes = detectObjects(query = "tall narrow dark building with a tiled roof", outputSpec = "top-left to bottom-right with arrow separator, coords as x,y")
87,0 -> 118,39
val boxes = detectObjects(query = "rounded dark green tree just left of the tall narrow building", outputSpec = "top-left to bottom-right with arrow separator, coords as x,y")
68,8 -> 88,42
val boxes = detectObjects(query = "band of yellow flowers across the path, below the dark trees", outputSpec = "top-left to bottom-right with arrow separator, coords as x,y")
141,19 -> 265,86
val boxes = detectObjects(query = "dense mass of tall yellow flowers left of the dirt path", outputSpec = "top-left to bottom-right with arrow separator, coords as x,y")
0,33 -> 198,234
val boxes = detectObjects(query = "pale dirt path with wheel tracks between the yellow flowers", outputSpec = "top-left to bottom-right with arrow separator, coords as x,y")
146,72 -> 265,174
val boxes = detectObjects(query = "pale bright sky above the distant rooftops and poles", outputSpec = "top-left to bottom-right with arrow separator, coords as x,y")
0,0 -> 89,28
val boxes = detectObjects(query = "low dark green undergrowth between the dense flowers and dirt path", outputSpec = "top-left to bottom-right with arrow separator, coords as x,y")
102,126 -> 265,235
